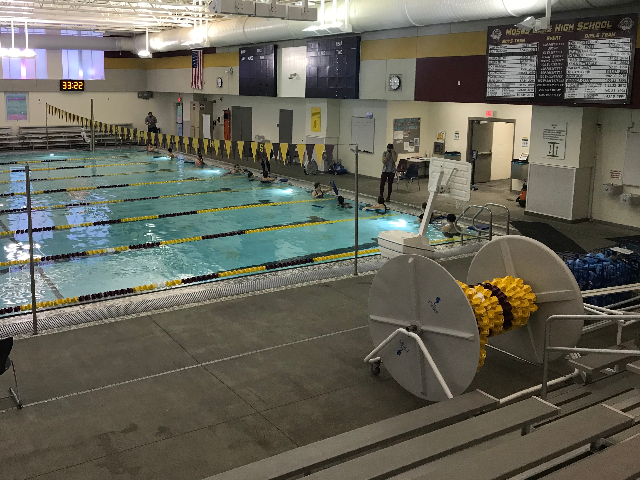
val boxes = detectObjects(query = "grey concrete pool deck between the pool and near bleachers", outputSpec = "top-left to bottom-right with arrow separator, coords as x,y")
0,253 -> 634,480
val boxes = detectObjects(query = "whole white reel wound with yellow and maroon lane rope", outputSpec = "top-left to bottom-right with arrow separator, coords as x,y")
364,235 -> 584,401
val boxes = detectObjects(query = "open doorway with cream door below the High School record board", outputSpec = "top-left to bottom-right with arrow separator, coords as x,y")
467,118 -> 516,183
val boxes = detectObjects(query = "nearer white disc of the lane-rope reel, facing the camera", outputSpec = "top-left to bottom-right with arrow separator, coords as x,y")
369,255 -> 480,401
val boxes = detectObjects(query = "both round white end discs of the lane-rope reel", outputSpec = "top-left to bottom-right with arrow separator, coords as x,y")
369,236 -> 583,401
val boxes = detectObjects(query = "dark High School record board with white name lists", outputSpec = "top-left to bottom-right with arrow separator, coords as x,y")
486,14 -> 638,105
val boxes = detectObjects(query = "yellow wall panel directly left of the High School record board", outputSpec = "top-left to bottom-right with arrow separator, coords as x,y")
417,32 -> 487,58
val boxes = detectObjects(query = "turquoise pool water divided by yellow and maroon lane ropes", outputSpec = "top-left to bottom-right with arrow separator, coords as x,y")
0,149 -> 450,307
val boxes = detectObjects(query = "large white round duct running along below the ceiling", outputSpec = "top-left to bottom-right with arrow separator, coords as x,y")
0,0 -> 637,54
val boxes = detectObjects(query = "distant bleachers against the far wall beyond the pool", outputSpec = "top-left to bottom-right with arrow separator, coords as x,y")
0,124 -> 133,150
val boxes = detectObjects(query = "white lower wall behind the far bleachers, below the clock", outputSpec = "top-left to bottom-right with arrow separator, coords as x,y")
0,92 -> 175,133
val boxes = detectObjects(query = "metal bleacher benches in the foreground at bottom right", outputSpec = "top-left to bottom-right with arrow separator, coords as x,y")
208,348 -> 640,480
